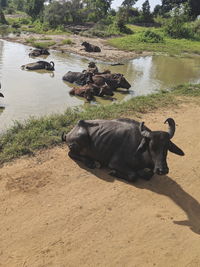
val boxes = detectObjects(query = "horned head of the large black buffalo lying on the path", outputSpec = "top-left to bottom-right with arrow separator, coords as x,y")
137,118 -> 184,175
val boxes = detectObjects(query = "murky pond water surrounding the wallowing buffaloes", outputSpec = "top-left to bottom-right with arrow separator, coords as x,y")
0,40 -> 200,131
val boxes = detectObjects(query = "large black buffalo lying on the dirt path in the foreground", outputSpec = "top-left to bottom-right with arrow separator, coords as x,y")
62,118 -> 184,182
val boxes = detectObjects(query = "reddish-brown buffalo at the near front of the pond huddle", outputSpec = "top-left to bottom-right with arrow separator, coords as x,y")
69,83 -> 114,101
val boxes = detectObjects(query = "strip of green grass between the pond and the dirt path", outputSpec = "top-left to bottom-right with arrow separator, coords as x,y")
0,84 -> 200,163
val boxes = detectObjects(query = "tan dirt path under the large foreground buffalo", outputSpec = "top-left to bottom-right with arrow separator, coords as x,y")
0,103 -> 200,267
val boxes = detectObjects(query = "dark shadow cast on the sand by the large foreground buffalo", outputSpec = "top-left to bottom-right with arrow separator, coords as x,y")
76,161 -> 200,234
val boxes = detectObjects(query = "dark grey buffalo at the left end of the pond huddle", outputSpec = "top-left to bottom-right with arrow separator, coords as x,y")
63,71 -> 93,85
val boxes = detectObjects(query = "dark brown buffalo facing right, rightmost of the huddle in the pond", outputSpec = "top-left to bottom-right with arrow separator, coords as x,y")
91,73 -> 131,90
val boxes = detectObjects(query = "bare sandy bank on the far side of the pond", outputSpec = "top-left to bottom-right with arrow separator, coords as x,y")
2,33 -> 152,63
